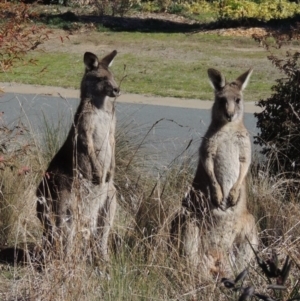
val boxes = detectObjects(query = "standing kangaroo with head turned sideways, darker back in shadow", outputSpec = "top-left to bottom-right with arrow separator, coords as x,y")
36,51 -> 119,260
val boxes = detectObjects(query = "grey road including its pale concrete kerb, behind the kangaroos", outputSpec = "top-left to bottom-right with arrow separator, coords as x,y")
0,83 -> 256,172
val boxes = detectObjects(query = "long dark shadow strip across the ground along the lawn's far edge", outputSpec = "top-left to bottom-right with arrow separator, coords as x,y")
39,11 -> 300,33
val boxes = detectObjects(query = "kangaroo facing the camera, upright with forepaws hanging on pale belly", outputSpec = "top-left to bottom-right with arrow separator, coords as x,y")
172,69 -> 258,271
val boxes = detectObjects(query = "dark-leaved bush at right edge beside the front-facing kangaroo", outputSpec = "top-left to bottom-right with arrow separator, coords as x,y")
255,28 -> 300,177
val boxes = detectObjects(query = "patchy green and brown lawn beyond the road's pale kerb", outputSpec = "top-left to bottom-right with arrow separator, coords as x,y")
0,31 -> 279,101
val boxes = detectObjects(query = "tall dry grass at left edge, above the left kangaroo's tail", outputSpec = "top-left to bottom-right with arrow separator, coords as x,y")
0,116 -> 39,246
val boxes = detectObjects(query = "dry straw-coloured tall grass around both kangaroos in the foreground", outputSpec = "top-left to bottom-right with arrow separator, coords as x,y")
0,108 -> 300,301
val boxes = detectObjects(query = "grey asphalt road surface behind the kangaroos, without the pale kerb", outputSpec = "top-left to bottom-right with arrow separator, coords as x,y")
0,93 -> 257,170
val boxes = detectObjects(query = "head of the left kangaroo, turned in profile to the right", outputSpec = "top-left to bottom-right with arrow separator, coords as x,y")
81,50 -> 120,98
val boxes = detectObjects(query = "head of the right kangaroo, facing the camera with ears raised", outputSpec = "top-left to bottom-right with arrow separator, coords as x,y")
207,69 -> 253,123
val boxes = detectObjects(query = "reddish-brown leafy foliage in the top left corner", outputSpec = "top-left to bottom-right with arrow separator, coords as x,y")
0,1 -> 49,72
